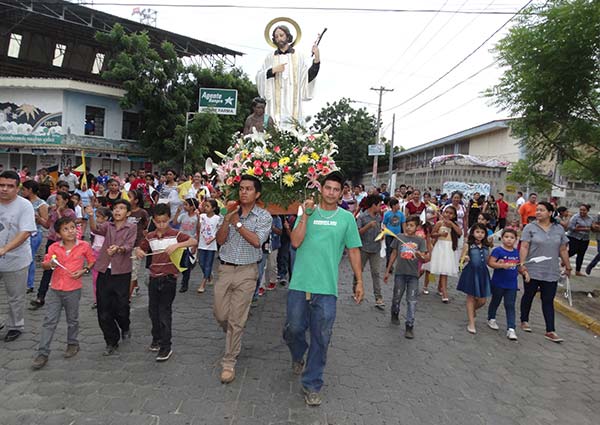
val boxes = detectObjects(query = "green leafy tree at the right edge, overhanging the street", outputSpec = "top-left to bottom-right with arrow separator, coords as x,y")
488,0 -> 600,181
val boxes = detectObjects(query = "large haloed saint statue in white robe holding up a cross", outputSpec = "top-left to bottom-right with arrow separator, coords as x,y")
256,20 -> 321,128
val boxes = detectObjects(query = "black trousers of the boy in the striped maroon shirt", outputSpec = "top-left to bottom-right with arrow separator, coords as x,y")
148,275 -> 177,350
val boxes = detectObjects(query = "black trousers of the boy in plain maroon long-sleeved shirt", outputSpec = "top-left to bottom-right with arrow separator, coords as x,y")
96,269 -> 131,346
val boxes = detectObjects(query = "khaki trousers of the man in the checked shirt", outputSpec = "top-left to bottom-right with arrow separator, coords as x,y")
213,264 -> 258,369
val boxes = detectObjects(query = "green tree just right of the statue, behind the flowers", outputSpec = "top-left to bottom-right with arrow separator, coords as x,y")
312,98 -> 377,179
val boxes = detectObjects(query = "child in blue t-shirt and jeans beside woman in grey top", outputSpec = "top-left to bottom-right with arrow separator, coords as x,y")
488,229 -> 520,341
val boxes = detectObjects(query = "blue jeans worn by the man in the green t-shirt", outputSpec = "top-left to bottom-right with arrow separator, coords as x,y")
283,290 -> 337,392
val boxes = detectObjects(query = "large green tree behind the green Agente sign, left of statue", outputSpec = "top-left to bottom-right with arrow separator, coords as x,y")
96,24 -> 257,172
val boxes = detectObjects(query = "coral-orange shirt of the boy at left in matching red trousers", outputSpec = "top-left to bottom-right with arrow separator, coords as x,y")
44,240 -> 95,291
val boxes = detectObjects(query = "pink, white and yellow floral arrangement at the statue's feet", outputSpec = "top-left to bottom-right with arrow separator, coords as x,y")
215,128 -> 338,208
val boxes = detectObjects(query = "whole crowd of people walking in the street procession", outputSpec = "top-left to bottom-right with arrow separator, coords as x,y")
0,163 -> 600,406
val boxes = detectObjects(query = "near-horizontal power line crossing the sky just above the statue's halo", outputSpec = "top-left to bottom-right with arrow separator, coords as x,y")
72,0 -> 536,15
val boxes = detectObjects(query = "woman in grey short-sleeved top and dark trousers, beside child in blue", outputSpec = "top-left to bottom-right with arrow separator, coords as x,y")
520,201 -> 571,342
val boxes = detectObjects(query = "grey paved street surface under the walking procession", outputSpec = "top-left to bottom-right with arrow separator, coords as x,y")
0,260 -> 600,425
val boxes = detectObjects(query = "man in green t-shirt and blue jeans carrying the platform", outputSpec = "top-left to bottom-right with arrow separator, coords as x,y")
283,172 -> 364,406
